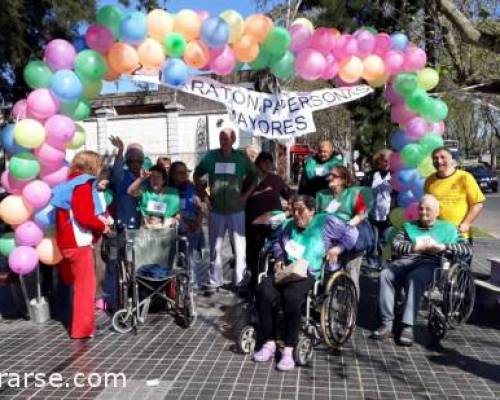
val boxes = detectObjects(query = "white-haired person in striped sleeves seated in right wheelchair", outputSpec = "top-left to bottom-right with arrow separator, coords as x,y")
372,195 -> 471,346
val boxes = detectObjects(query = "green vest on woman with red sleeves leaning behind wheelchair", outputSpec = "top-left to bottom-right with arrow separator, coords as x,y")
316,186 -> 373,222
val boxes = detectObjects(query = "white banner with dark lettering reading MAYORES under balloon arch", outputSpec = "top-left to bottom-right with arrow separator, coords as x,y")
133,75 -> 373,139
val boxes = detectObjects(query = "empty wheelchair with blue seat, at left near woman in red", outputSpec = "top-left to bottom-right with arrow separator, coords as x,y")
111,227 -> 197,333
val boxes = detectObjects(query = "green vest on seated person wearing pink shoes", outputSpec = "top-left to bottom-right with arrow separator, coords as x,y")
283,214 -> 328,278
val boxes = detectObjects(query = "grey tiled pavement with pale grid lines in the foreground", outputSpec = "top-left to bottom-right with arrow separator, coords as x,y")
0,239 -> 500,400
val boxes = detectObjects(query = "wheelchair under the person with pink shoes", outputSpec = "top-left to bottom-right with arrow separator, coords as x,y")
233,241 -> 358,365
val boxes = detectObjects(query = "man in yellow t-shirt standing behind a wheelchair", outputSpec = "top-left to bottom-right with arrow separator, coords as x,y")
425,147 -> 486,239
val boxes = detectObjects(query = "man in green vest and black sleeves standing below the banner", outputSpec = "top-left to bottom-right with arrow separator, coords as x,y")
298,140 -> 343,197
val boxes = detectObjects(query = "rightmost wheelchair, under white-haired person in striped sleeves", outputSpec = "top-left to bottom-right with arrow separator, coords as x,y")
425,255 -> 476,340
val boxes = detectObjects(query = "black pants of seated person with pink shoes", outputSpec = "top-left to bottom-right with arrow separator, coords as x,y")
257,277 -> 314,347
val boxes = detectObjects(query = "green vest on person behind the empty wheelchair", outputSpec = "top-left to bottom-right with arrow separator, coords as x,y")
139,187 -> 180,218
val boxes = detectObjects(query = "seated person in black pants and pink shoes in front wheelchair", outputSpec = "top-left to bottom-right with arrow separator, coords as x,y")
254,195 -> 358,371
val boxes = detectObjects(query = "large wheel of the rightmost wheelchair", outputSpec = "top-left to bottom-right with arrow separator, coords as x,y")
443,264 -> 476,327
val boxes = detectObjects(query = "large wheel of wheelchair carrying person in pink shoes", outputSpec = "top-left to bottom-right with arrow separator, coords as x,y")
320,271 -> 358,348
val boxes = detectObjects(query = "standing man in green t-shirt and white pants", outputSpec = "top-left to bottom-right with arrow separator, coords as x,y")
194,124 -> 257,288
